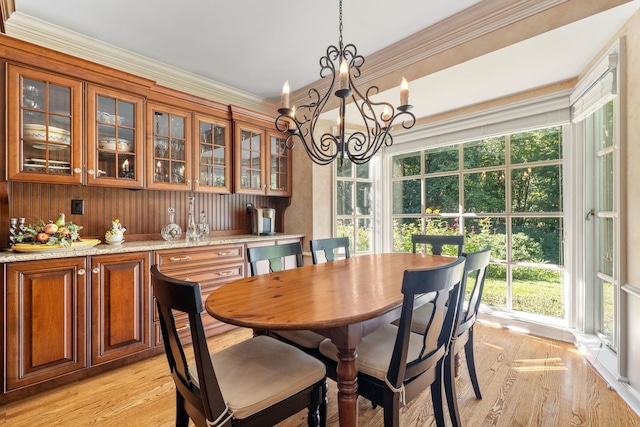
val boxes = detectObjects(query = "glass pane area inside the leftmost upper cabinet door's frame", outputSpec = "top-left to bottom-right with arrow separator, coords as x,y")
20,78 -> 72,175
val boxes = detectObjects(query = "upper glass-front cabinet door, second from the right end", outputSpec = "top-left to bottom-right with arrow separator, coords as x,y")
234,122 -> 266,194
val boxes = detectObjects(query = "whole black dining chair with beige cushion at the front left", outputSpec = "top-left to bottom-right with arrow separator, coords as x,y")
151,265 -> 326,427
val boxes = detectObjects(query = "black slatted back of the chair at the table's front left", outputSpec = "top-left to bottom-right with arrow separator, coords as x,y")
151,265 -> 226,422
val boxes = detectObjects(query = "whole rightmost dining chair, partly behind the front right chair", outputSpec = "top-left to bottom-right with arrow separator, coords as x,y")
411,248 -> 491,427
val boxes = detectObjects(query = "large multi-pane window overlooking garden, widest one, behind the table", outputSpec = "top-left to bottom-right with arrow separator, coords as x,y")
391,127 -> 565,319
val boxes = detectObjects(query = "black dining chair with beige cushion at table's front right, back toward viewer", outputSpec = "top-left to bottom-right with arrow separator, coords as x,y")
320,257 -> 466,427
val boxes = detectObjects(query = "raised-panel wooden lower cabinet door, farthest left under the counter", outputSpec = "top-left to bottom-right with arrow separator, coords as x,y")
5,257 -> 87,391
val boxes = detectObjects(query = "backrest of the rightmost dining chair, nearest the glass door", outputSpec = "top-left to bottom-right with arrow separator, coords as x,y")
458,248 -> 491,334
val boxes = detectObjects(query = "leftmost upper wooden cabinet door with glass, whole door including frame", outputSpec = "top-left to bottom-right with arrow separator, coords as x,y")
7,64 -> 82,184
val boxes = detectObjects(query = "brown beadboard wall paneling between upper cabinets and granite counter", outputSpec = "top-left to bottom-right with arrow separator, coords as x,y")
5,182 -> 290,242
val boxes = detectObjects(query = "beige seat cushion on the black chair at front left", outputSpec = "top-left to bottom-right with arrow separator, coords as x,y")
189,335 -> 326,419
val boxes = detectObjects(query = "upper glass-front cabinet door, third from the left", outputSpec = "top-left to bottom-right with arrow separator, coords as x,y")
146,102 -> 192,190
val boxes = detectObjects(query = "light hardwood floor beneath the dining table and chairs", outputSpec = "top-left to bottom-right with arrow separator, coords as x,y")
0,324 -> 640,427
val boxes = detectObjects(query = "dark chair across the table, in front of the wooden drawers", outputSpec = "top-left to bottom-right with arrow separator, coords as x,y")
247,242 -> 325,357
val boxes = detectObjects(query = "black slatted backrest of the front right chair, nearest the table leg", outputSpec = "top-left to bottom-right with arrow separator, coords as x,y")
388,257 -> 466,388
